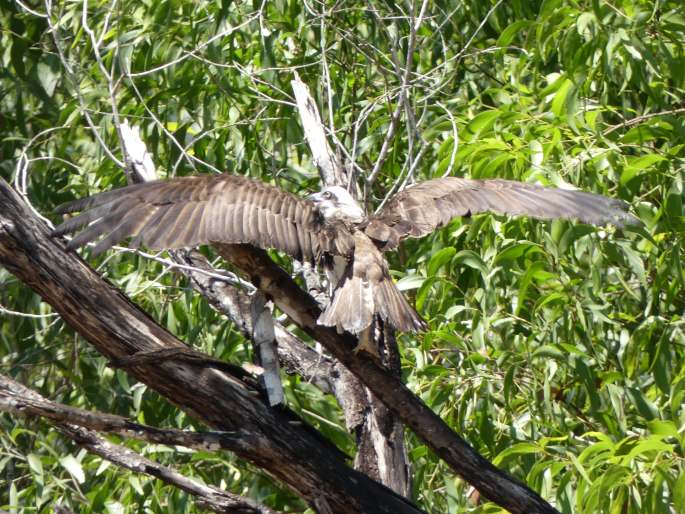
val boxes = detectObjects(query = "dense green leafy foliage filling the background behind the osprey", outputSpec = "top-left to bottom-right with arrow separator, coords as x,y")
0,0 -> 685,513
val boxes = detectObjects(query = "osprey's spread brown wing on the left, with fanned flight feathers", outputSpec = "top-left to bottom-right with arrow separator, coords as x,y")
54,175 -> 354,261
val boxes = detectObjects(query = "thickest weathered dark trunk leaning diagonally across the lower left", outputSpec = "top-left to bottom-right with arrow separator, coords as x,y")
0,179 -> 421,514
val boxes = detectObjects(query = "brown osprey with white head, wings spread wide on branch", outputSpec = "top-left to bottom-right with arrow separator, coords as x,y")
53,175 -> 635,333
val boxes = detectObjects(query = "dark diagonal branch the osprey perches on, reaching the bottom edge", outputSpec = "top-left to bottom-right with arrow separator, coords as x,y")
216,245 -> 558,514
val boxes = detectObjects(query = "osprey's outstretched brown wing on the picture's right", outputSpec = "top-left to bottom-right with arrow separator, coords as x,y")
365,177 -> 637,250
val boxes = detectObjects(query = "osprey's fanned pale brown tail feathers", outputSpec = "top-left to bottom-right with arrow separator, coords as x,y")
319,276 -> 426,334
